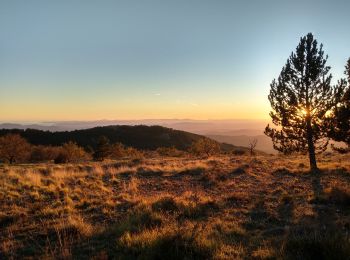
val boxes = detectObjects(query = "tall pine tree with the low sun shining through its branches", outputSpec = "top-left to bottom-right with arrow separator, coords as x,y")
265,33 -> 344,170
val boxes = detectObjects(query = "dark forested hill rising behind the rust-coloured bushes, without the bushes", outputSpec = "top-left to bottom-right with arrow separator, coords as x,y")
0,125 -> 252,151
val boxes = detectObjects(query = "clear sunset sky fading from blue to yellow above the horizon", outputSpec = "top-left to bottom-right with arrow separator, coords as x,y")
0,0 -> 350,122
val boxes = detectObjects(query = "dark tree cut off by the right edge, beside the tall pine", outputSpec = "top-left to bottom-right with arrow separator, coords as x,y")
329,58 -> 350,152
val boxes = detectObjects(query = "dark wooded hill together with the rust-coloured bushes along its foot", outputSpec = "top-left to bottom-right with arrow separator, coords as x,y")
0,126 -> 247,164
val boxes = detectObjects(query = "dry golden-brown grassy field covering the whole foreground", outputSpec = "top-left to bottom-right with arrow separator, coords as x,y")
0,154 -> 350,259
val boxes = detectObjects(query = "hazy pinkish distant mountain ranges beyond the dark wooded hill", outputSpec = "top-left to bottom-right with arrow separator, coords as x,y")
0,119 -> 276,153
